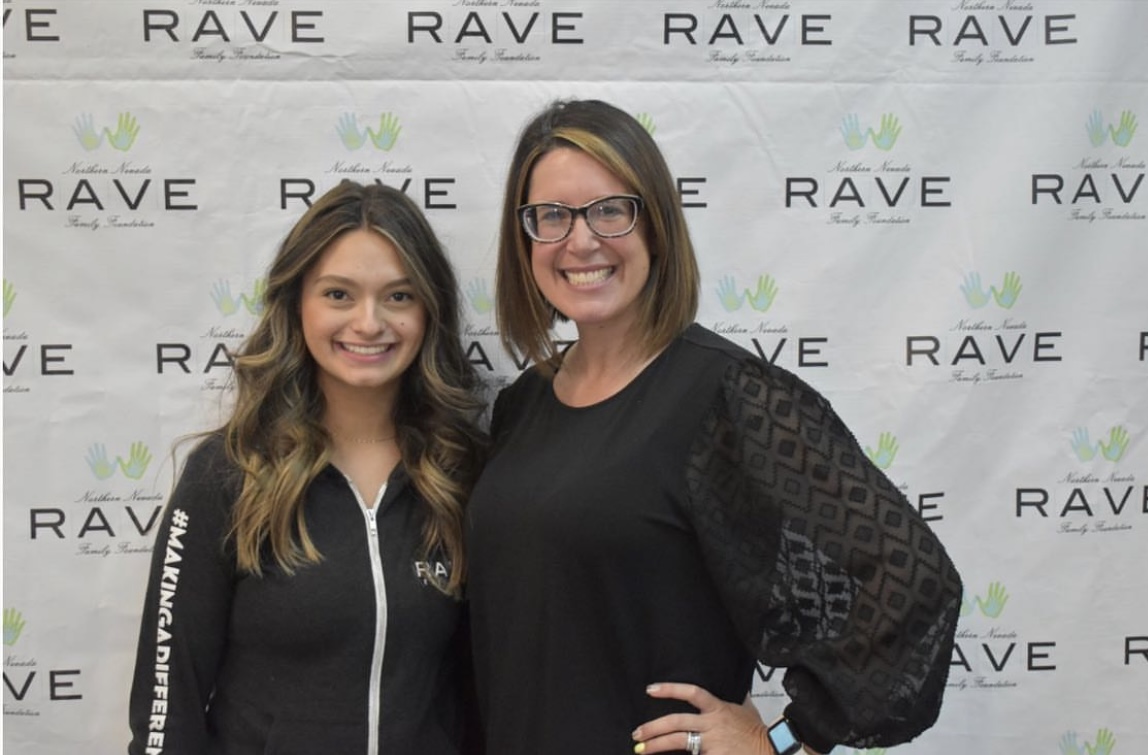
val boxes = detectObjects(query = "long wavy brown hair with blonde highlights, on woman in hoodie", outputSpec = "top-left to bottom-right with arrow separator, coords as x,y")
222,180 -> 484,594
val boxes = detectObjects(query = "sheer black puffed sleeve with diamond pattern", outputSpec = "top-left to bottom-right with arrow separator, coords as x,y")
687,359 -> 961,752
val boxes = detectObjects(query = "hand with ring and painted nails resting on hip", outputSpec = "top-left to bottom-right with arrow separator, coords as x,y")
634,683 -> 773,755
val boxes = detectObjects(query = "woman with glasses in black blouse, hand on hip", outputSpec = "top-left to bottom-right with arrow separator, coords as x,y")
467,101 -> 961,755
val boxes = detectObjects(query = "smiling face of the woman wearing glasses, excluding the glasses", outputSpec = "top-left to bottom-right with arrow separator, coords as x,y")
527,147 -> 650,335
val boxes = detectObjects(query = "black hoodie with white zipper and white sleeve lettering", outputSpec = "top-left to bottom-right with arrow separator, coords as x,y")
127,435 -> 471,755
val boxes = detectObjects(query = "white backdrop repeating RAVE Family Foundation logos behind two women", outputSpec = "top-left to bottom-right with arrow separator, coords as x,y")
2,0 -> 1148,755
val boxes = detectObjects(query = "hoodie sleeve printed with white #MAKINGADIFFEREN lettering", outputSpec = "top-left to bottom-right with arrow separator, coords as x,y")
127,437 -> 234,755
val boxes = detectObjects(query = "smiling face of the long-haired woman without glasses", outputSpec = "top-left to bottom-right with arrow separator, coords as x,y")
300,228 -> 426,399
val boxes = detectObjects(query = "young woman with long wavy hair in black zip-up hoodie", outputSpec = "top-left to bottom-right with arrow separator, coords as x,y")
129,181 -> 483,755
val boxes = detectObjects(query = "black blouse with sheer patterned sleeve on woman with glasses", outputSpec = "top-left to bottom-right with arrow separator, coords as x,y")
468,326 -> 961,755
